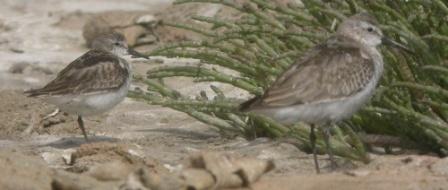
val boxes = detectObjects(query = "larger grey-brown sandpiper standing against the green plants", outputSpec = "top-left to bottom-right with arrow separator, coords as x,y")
241,13 -> 407,173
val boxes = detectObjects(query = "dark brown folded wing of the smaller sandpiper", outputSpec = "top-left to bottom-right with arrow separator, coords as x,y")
27,50 -> 129,96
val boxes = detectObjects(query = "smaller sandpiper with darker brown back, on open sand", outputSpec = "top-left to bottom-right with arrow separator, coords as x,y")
25,33 -> 146,141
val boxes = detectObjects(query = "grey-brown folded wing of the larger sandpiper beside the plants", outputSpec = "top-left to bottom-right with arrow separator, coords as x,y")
249,38 -> 374,109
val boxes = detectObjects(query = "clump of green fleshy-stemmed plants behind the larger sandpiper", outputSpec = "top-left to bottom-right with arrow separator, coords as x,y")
130,0 -> 448,162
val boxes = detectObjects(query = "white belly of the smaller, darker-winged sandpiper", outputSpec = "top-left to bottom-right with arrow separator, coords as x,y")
46,82 -> 129,116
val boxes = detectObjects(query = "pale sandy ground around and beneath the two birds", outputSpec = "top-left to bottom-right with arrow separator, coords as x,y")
0,0 -> 448,190
